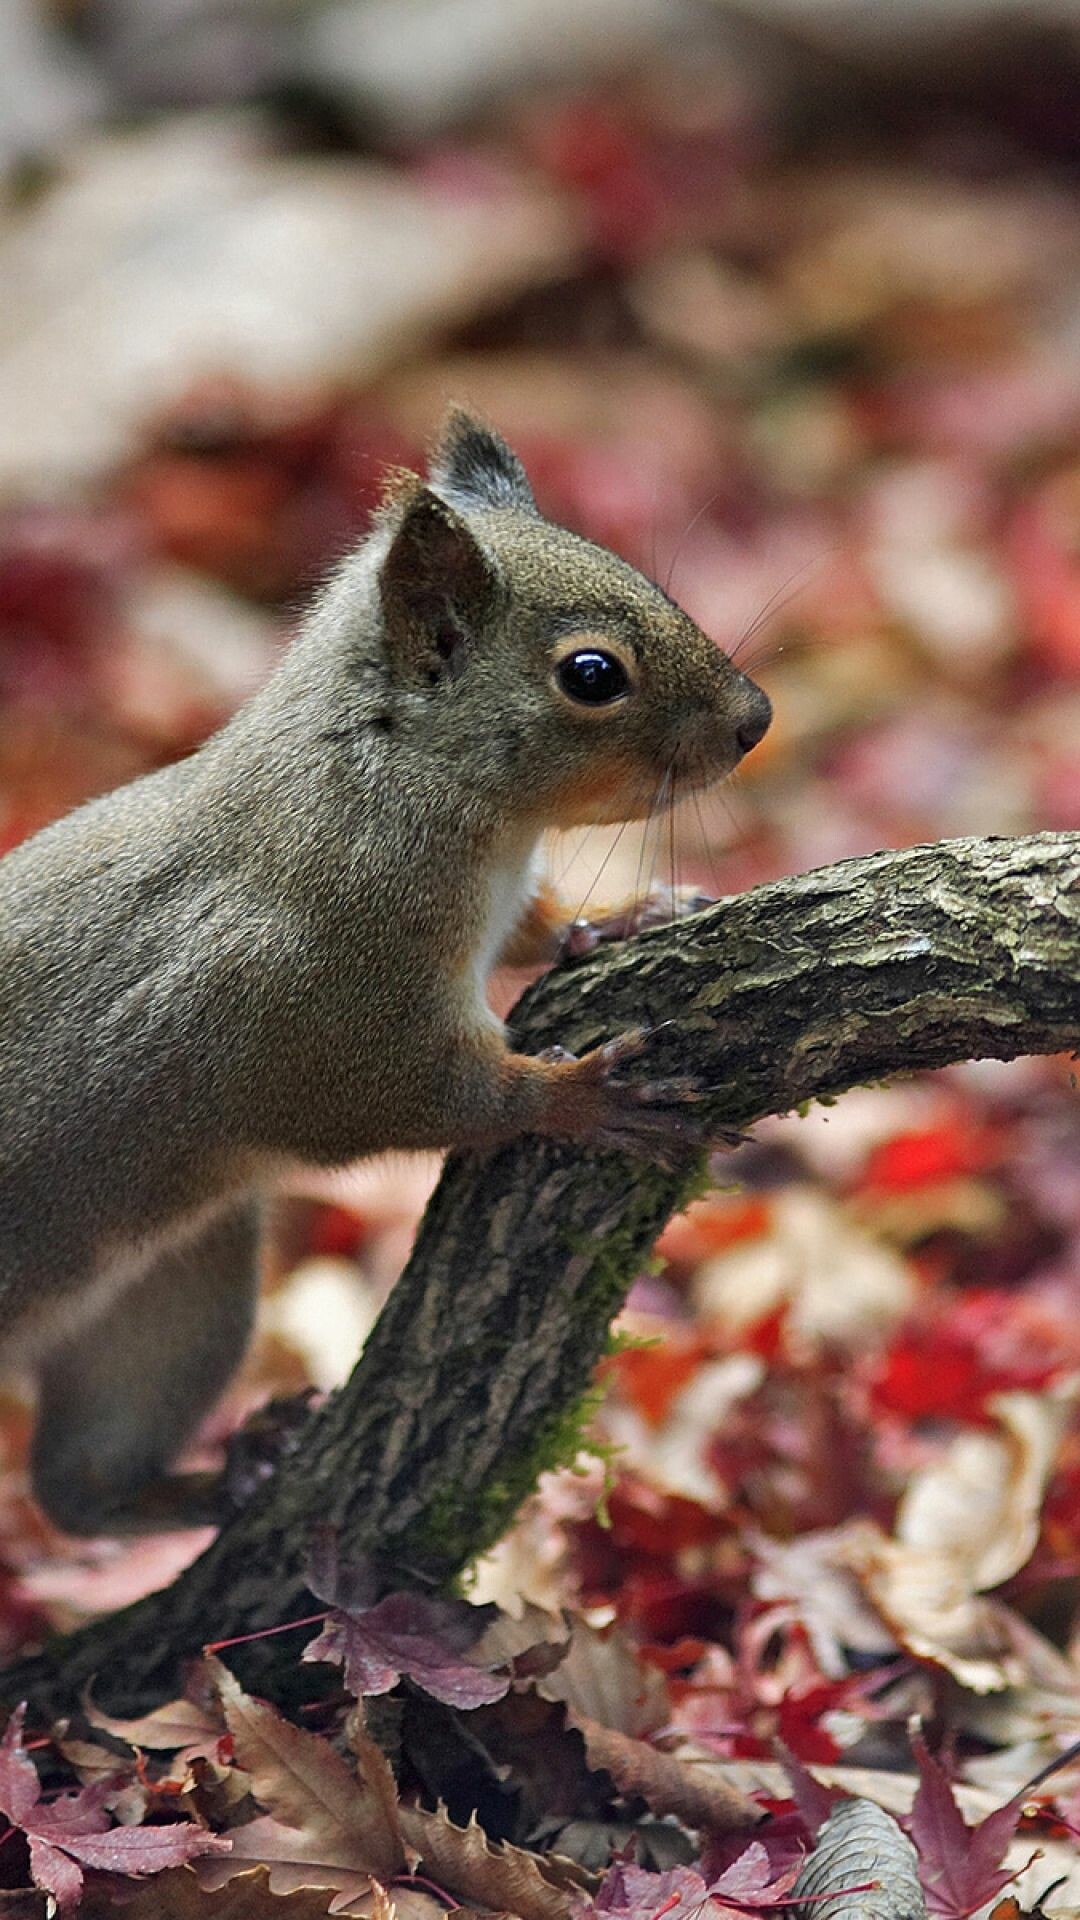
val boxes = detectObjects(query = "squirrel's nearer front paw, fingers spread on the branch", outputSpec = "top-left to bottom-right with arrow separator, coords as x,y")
544,1027 -> 742,1169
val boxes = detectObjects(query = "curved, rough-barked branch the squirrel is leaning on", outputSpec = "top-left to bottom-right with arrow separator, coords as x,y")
2,833 -> 1080,1711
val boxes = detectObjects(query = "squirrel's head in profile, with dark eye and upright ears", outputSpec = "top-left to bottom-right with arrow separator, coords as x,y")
367,413 -> 771,826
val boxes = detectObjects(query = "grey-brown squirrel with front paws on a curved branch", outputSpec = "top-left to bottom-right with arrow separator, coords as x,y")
0,413 -> 771,1534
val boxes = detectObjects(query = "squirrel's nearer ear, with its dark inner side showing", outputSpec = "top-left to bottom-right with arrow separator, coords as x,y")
379,486 -> 498,685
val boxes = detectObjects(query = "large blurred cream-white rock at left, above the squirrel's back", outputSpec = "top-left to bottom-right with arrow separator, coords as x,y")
0,115 -> 577,490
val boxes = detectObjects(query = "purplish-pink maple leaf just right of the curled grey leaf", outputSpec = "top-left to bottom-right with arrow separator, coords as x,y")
911,1734 -> 1024,1920
